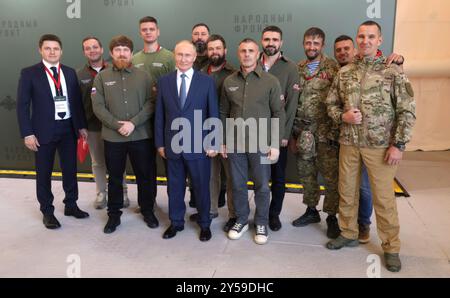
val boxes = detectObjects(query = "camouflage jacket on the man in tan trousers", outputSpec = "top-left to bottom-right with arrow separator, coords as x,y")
327,56 -> 416,148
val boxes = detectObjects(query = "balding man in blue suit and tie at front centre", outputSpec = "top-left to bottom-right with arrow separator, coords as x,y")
155,40 -> 220,241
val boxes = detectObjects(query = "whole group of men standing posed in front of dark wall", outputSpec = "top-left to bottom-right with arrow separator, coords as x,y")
17,17 -> 415,271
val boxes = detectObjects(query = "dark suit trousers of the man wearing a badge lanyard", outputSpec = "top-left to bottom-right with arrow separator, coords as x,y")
35,119 -> 78,215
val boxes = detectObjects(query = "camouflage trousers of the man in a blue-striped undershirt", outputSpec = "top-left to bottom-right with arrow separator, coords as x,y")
297,142 -> 339,215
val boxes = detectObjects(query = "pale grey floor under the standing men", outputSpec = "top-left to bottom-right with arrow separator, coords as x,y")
0,151 -> 450,278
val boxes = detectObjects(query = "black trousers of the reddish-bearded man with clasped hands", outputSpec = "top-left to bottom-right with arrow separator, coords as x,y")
105,139 -> 156,216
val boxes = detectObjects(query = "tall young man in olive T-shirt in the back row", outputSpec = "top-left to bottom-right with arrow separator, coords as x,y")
131,16 -> 175,213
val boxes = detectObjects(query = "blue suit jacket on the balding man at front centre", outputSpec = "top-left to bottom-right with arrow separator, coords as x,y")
155,71 -> 219,160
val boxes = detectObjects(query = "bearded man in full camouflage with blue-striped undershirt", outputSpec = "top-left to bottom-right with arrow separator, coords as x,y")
292,27 -> 340,239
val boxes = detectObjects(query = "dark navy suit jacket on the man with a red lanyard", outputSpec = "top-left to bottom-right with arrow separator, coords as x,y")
17,62 -> 87,144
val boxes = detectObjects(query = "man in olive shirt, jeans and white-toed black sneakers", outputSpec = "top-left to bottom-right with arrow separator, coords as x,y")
220,38 -> 285,245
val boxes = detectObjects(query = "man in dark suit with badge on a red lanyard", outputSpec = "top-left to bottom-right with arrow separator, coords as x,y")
17,34 -> 89,229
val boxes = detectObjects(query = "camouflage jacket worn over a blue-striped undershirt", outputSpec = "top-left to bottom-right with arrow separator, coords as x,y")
293,54 -> 339,142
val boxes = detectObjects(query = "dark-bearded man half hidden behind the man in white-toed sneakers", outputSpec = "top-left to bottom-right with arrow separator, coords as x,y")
259,26 -> 300,231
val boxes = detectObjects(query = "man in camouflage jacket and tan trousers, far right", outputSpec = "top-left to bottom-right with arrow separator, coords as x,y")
326,21 -> 416,272
